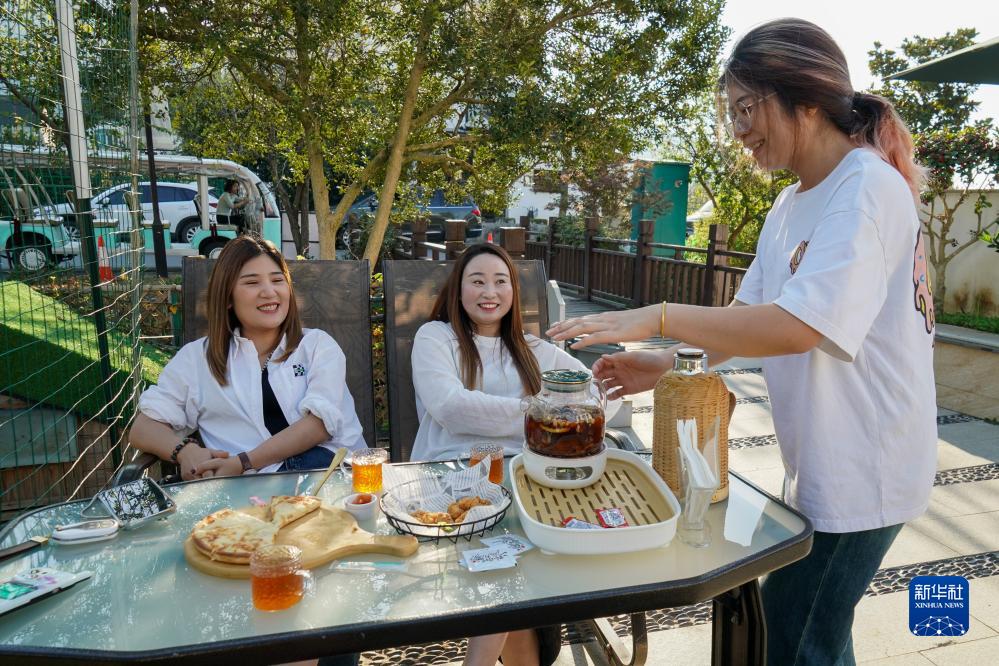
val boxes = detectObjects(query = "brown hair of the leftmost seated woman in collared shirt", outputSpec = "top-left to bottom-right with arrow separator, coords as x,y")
200,235 -> 302,386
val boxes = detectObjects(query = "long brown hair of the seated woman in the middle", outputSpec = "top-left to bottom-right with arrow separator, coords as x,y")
430,243 -> 541,395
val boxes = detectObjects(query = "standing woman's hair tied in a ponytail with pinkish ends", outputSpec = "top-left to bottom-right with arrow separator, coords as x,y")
721,18 -> 923,197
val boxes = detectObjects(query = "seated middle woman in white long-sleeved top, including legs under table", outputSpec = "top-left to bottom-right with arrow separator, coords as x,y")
411,243 -> 586,666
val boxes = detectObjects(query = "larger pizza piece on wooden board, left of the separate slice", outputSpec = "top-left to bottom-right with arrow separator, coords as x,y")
191,509 -> 278,565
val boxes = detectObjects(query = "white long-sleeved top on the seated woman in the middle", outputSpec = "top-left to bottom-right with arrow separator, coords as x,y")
410,321 -> 586,460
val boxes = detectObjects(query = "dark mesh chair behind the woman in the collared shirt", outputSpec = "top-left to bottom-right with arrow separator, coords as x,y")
115,257 -> 376,485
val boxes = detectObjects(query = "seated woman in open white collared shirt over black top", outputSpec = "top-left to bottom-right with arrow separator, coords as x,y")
129,236 -> 366,480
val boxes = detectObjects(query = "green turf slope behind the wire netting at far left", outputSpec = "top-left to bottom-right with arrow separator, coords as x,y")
0,280 -> 169,416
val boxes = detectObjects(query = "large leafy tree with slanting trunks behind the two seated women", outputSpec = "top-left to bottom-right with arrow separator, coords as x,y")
144,0 -> 724,262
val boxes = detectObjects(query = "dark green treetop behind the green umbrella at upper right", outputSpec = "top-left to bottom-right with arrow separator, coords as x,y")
868,28 -> 979,134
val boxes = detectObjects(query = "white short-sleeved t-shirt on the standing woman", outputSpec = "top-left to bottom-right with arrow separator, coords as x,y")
736,148 -> 937,533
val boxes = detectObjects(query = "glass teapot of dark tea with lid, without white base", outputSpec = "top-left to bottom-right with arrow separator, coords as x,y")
521,370 -> 607,458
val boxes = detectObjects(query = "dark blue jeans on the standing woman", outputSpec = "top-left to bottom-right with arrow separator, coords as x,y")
760,525 -> 904,666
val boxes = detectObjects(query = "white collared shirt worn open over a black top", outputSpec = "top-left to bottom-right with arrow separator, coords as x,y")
139,328 -> 367,472
